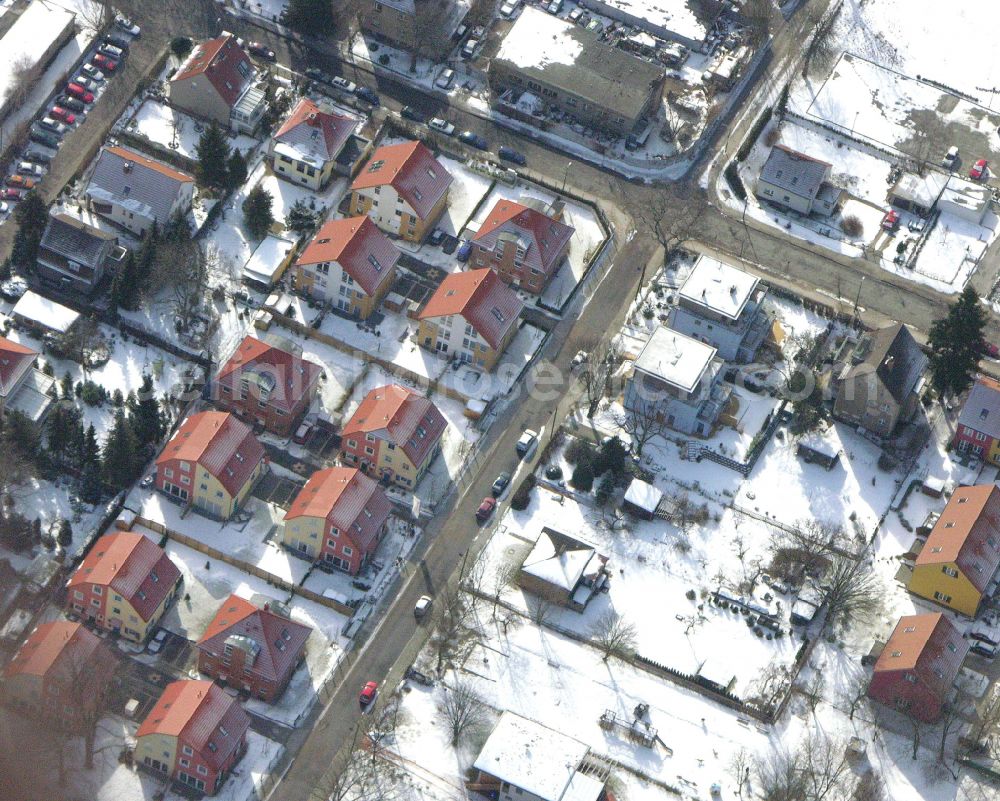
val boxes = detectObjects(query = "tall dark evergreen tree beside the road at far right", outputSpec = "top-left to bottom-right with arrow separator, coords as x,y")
927,286 -> 986,396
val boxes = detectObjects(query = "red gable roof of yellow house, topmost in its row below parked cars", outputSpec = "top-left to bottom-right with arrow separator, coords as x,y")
351,142 -> 451,218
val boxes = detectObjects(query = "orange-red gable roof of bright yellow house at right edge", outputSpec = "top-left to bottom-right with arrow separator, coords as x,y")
916,484 -> 1000,593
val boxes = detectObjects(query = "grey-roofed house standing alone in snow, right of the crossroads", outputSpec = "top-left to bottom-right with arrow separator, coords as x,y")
755,145 -> 844,215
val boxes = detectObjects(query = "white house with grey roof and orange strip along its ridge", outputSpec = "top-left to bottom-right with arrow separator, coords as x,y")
84,146 -> 194,236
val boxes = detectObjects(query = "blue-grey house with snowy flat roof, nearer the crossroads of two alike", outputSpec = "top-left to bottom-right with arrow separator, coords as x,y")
669,255 -> 771,364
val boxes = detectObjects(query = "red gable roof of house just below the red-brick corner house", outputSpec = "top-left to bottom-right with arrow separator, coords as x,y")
419,267 -> 524,350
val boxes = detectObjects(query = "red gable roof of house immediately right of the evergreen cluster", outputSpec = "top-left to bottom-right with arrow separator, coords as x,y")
156,412 -> 264,496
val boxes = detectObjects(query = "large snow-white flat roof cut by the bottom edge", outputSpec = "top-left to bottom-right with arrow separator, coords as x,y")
473,712 -> 603,801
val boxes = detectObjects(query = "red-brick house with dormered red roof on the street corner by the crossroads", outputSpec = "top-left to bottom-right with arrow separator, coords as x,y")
470,200 -> 575,295
